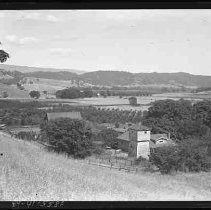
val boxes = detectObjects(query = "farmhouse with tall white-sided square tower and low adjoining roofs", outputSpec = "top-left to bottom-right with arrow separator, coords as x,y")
117,124 -> 175,159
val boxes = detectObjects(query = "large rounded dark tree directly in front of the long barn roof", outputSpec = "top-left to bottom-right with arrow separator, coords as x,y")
41,118 -> 92,158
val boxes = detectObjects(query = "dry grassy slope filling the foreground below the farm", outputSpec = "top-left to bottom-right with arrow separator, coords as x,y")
0,134 -> 211,201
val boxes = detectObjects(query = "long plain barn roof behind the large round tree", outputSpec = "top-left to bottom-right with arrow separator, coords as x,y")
47,112 -> 82,120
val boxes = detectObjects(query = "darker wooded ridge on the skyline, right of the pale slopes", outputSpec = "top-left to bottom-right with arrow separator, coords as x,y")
80,71 -> 211,87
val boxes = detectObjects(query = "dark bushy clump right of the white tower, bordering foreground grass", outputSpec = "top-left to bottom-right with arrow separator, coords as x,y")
150,140 -> 211,174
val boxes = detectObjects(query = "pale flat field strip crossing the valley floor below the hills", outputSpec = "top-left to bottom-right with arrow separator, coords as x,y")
1,90 -> 211,111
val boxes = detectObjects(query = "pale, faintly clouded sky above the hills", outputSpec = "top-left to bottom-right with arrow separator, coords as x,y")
0,9 -> 211,75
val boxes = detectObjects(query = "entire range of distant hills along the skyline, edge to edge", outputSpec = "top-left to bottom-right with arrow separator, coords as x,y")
0,64 -> 211,87
